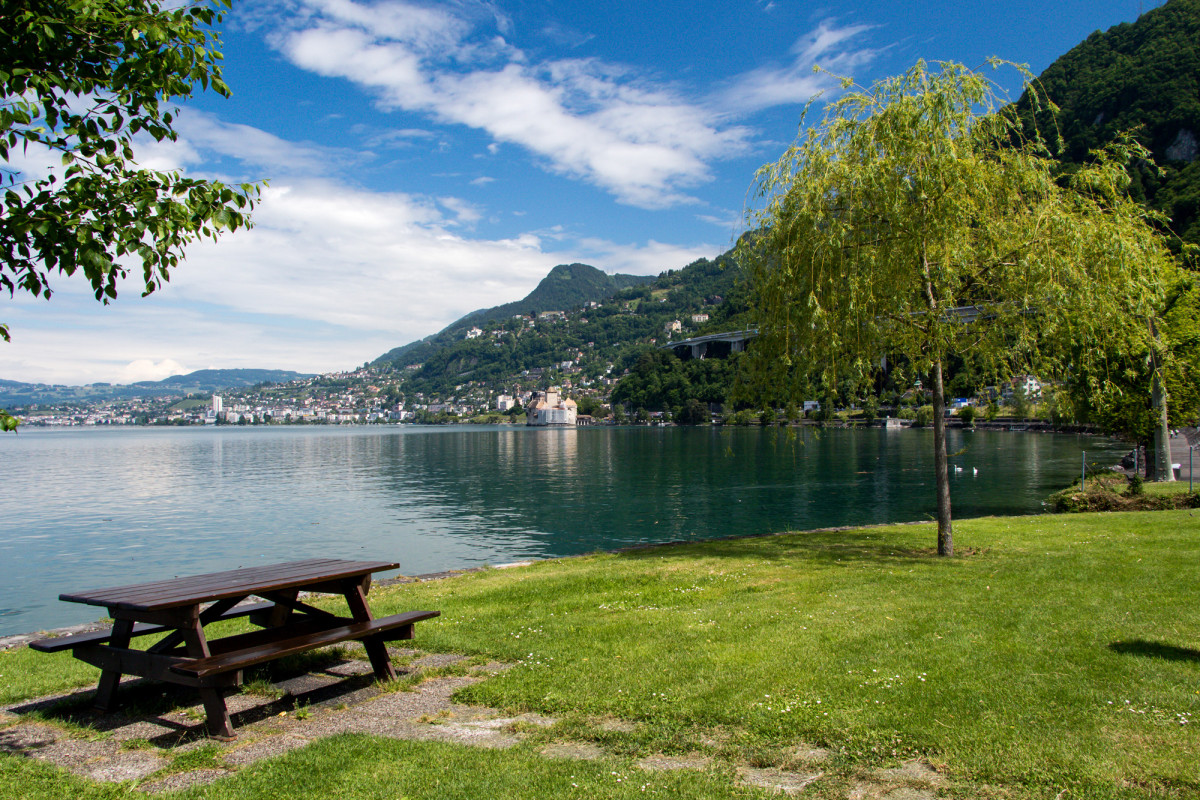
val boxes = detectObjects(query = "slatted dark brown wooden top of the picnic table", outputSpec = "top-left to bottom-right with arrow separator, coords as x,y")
59,559 -> 400,610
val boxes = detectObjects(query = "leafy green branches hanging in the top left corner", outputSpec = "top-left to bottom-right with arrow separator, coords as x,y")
0,0 -> 258,339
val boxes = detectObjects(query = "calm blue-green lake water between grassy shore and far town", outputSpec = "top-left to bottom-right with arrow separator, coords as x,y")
0,426 -> 1123,634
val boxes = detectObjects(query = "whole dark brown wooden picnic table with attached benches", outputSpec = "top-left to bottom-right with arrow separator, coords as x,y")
29,559 -> 439,739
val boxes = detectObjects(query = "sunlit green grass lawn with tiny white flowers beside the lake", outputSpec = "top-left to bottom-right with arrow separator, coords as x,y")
0,510 -> 1200,799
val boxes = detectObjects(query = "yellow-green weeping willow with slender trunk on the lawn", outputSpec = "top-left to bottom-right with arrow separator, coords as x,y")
740,61 -> 1174,555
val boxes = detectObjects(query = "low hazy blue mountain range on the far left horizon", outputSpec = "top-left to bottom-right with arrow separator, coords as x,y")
0,369 -> 312,408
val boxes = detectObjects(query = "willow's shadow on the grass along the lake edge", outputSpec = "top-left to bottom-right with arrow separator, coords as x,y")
620,528 -> 980,565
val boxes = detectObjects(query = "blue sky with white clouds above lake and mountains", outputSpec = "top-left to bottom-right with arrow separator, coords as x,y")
0,0 -> 1160,384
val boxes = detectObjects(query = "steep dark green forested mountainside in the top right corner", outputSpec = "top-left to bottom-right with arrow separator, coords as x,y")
1018,0 -> 1200,243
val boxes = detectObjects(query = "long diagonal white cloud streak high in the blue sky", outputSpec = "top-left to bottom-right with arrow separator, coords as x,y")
272,0 -> 749,207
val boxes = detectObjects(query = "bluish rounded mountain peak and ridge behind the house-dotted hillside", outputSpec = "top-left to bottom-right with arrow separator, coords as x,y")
374,264 -> 654,366
